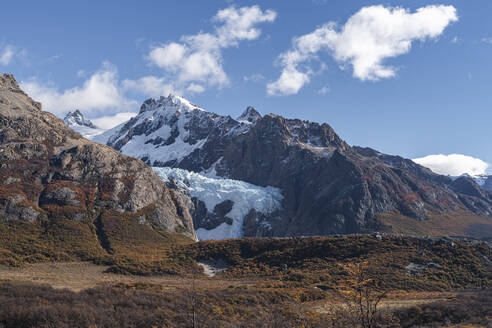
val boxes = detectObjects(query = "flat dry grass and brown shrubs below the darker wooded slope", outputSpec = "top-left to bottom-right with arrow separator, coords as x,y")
0,261 -> 492,328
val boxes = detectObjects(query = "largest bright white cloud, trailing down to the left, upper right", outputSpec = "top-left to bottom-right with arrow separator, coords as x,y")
267,5 -> 458,95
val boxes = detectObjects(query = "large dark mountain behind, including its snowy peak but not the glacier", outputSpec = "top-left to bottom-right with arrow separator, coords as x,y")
94,95 -> 492,236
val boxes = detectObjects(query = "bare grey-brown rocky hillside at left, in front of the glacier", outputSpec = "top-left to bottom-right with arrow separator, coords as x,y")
0,74 -> 196,240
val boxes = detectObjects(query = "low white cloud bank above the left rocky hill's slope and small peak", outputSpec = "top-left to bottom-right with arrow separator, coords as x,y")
21,63 -> 136,114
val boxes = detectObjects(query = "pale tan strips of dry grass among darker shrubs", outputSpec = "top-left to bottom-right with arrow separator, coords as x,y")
0,262 -> 463,313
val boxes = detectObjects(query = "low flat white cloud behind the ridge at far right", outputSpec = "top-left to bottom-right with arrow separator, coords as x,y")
413,154 -> 489,176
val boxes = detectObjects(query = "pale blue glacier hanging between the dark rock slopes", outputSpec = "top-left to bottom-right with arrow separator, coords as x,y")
153,167 -> 283,240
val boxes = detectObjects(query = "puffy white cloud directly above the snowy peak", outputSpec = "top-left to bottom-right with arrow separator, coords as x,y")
148,6 -> 277,93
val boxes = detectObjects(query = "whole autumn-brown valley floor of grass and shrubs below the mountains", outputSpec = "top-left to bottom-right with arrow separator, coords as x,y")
0,232 -> 492,328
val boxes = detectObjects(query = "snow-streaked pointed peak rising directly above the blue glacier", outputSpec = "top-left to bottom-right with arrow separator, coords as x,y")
102,95 -> 251,171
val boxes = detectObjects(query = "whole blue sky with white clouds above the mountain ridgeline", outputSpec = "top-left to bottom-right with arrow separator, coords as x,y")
0,0 -> 492,175
